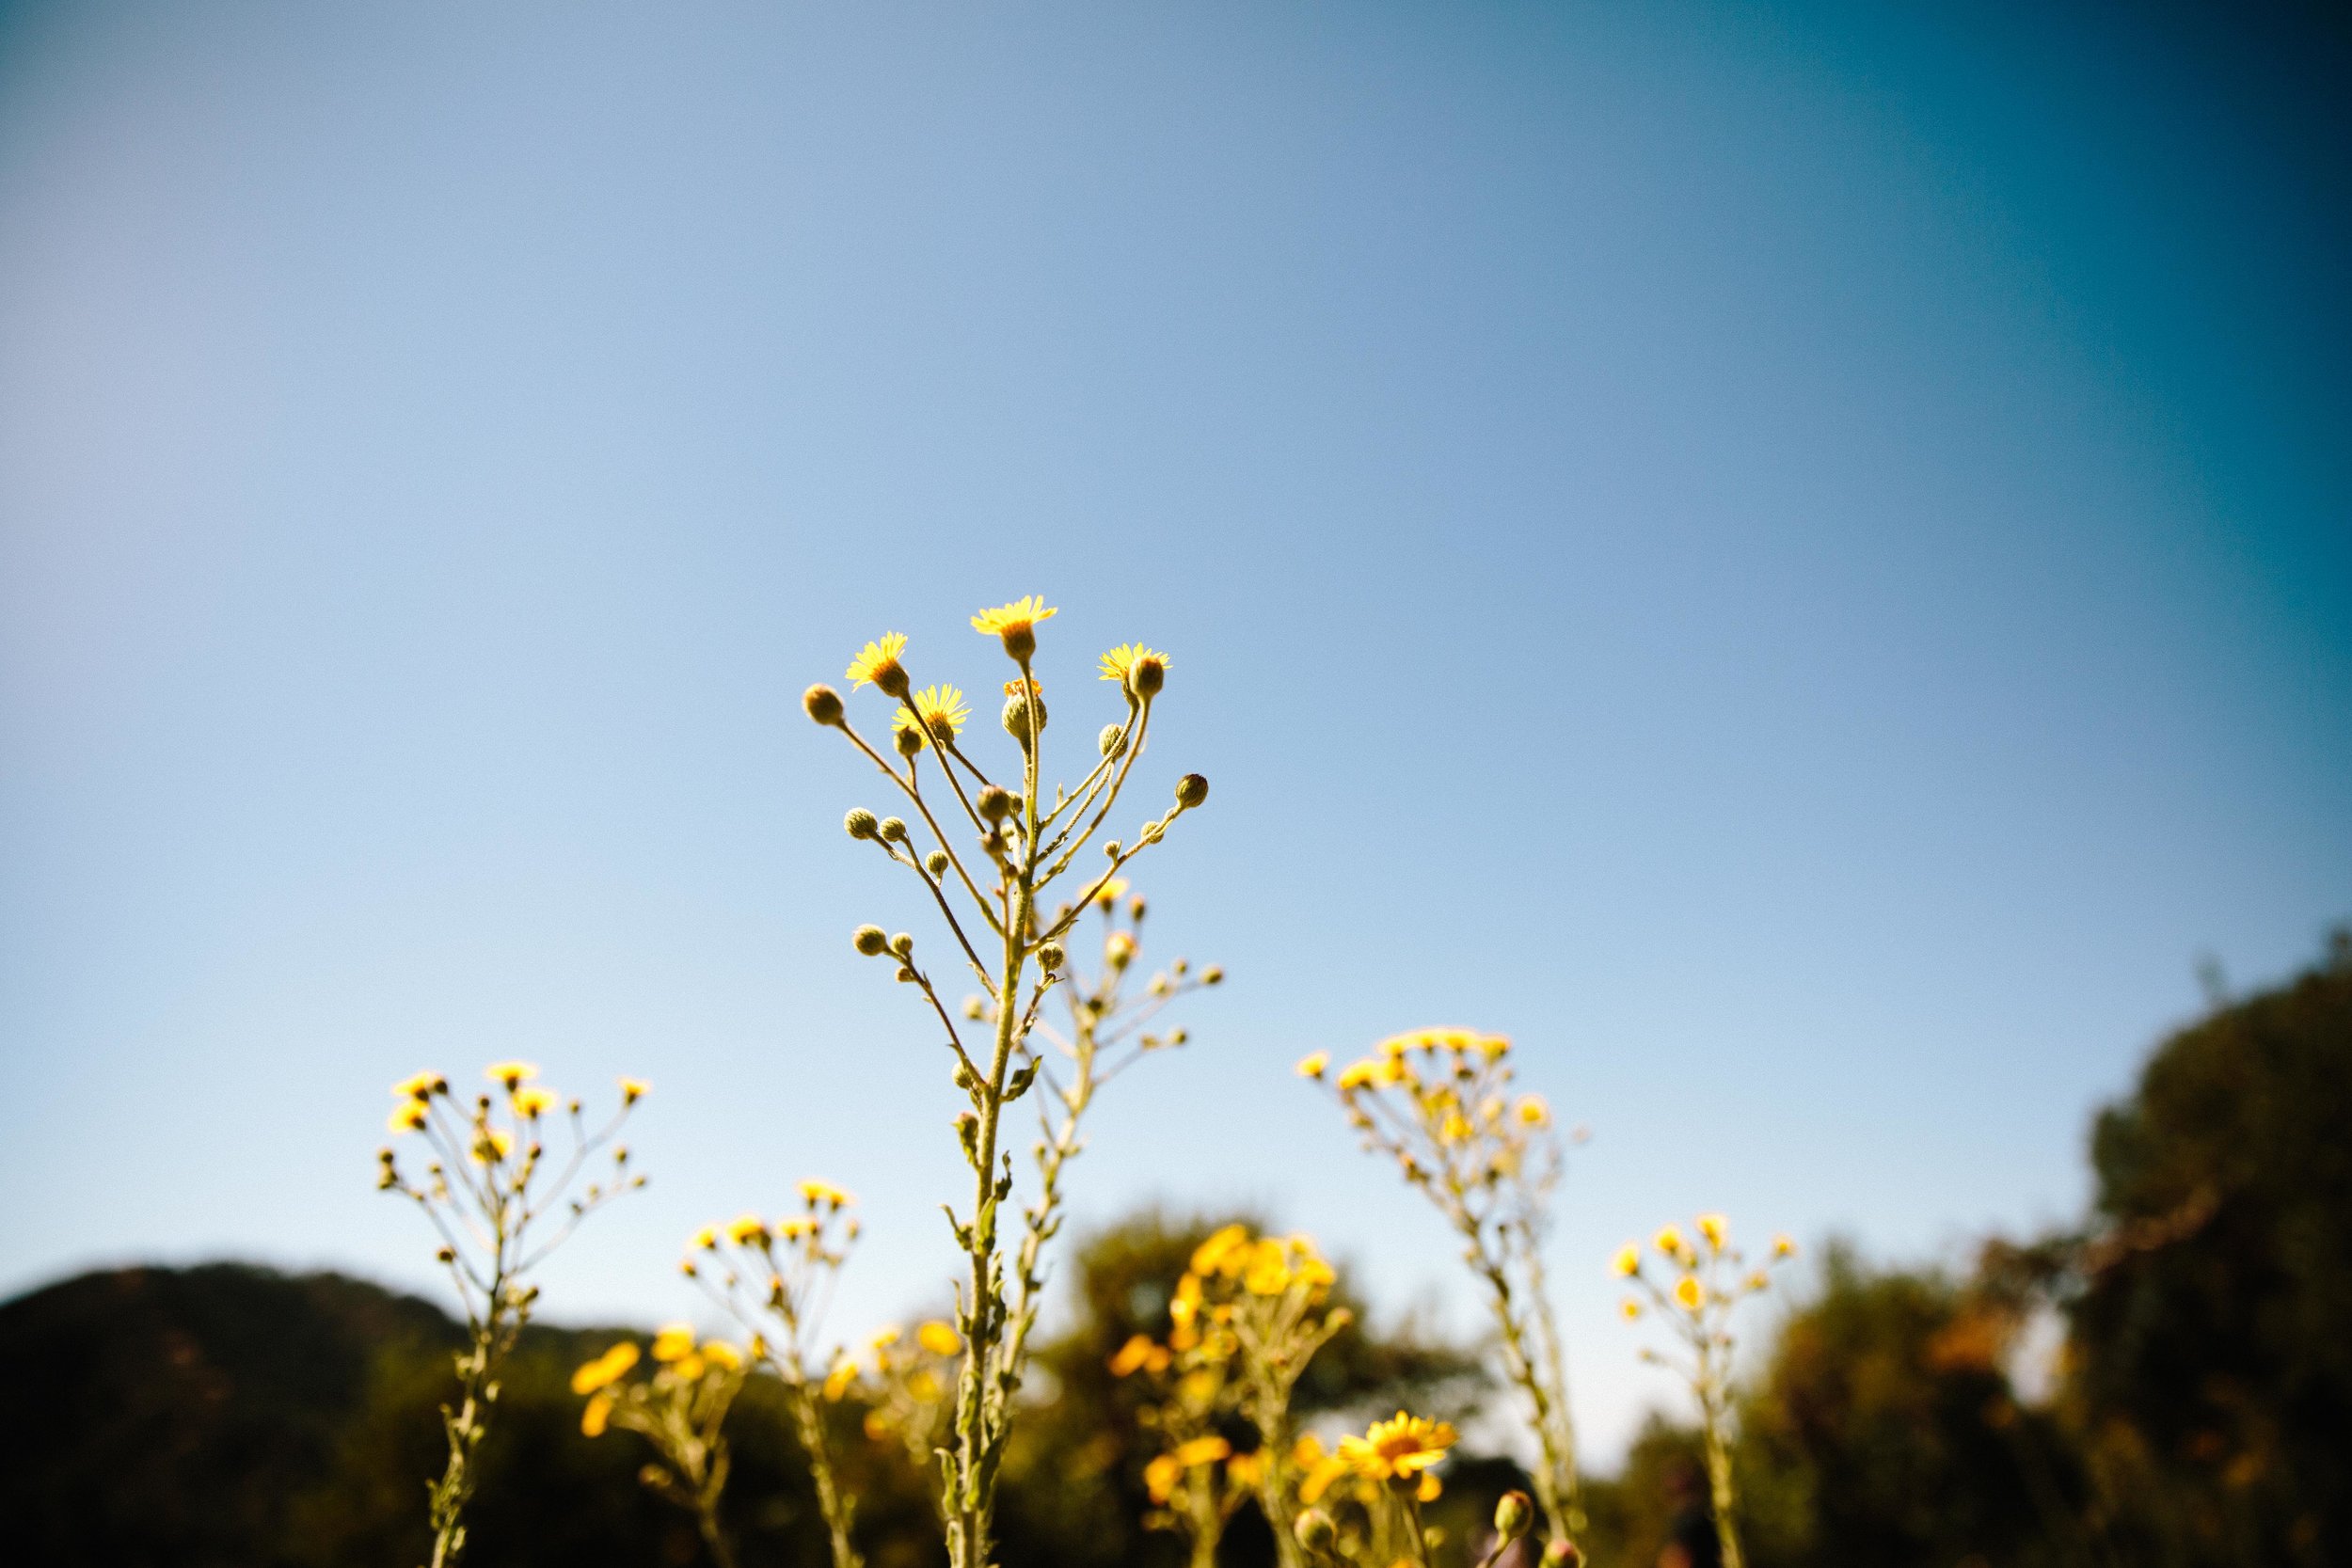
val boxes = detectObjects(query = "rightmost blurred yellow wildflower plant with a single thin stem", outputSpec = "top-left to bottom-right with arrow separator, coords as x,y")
1609,1213 -> 1797,1568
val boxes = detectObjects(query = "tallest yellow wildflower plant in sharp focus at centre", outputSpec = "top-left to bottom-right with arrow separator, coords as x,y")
803,594 -> 1209,1568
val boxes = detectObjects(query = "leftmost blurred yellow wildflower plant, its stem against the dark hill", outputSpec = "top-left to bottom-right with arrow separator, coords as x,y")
376,1063 -> 647,1568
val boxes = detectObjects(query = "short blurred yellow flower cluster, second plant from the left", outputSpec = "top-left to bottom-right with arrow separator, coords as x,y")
572,1323 -> 748,1568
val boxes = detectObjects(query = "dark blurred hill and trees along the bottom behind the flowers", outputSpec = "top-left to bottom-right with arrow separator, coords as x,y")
0,933 -> 2352,1568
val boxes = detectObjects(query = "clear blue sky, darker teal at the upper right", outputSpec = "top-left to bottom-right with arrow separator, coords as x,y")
0,2 -> 2352,1476
